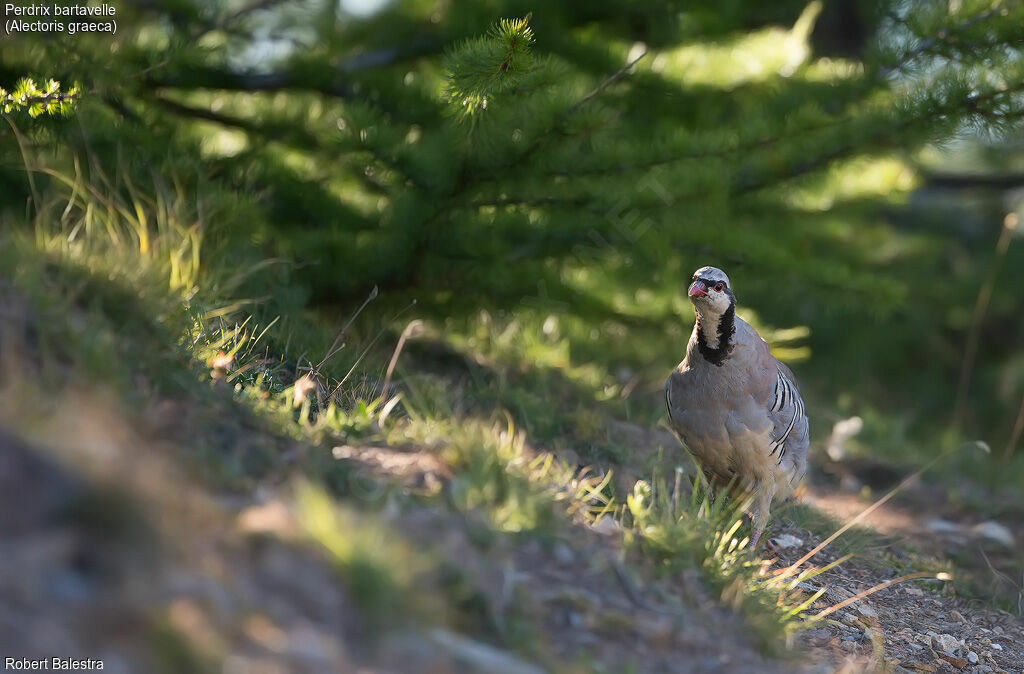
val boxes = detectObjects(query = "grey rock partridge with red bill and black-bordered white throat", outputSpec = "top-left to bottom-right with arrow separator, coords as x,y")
665,266 -> 808,550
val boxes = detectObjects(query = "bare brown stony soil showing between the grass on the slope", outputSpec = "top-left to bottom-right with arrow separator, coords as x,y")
0,383 -> 1024,674
